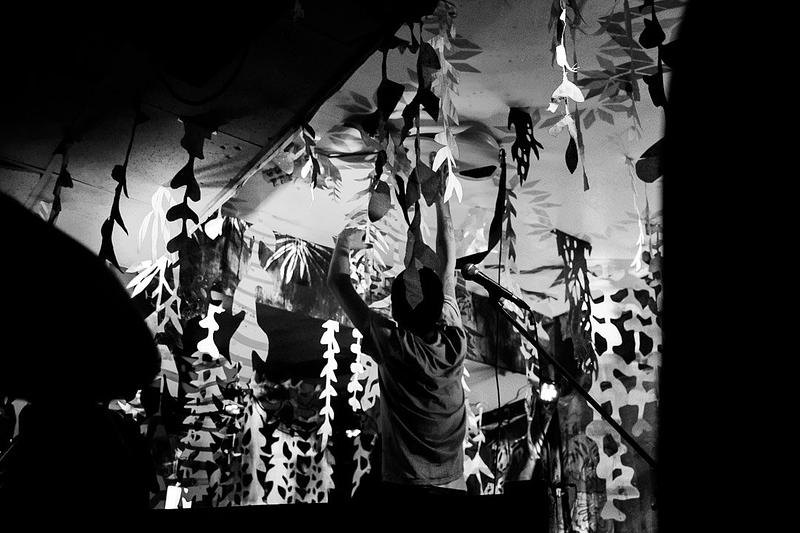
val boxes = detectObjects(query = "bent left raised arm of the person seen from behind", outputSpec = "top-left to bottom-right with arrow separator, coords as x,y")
328,228 -> 369,331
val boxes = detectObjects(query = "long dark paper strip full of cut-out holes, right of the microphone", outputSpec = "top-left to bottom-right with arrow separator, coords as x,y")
556,230 -> 597,376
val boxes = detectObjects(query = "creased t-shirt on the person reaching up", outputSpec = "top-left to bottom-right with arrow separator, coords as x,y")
363,270 -> 466,488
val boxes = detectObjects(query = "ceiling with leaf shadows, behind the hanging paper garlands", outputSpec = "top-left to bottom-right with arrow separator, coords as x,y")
0,0 -> 682,316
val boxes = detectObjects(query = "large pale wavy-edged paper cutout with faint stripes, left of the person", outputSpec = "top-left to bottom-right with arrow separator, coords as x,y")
228,232 -> 274,386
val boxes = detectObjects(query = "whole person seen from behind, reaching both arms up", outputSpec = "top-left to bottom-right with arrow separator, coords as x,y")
328,198 -> 467,499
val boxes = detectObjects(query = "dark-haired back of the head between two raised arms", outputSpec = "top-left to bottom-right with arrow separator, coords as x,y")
392,267 -> 444,335
